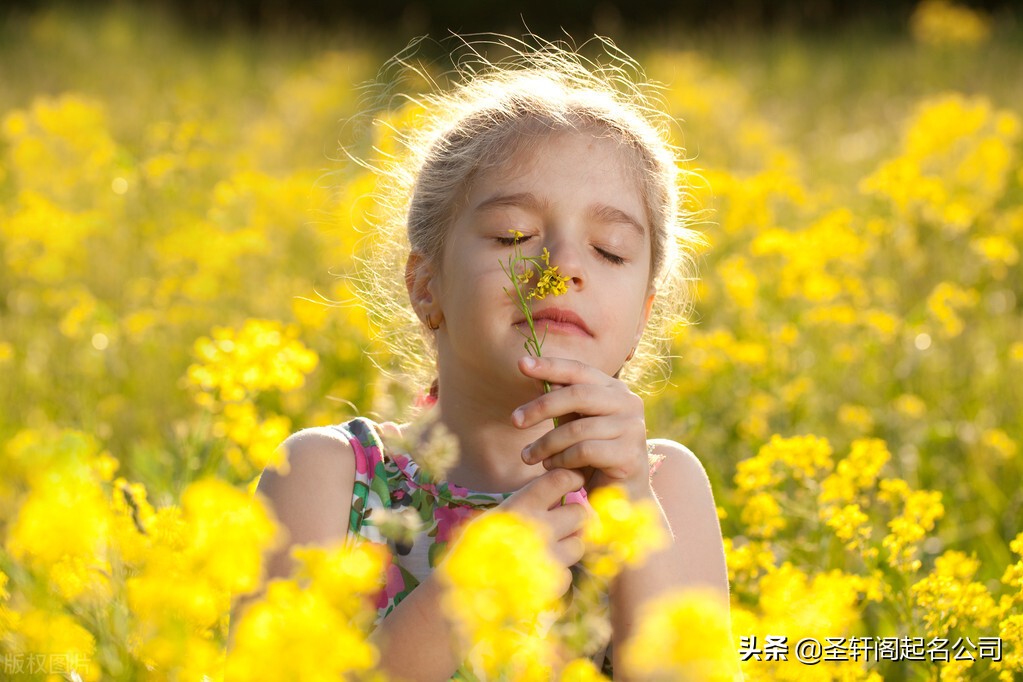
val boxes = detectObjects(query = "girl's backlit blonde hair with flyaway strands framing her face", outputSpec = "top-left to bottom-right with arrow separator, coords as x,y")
355,37 -> 703,402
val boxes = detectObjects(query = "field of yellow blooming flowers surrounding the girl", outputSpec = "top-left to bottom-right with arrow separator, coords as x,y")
0,2 -> 1023,680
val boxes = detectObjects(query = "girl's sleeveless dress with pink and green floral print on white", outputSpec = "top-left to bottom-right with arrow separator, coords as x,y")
331,417 -> 660,680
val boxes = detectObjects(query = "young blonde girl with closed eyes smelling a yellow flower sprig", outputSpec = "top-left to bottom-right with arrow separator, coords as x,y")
251,38 -> 728,680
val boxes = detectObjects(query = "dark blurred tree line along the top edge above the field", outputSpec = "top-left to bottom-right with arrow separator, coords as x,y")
0,0 -> 1018,37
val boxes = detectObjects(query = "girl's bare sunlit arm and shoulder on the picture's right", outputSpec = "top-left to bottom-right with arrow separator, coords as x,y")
610,440 -> 741,679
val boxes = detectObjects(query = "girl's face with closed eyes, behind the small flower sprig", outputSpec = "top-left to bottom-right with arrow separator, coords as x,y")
429,132 -> 654,392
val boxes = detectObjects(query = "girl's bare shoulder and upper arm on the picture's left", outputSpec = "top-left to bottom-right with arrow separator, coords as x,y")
256,426 -> 355,576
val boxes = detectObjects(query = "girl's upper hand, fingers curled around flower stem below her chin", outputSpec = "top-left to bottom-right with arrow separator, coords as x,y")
512,357 -> 653,499
